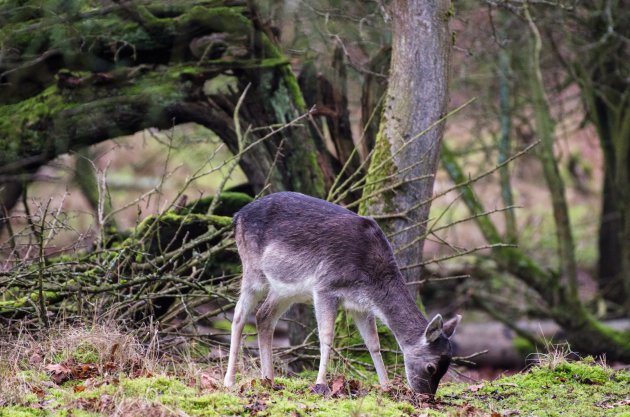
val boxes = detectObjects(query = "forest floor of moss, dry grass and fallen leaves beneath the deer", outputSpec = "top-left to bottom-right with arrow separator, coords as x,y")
0,329 -> 630,417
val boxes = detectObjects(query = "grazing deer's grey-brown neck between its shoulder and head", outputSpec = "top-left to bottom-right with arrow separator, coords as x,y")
379,277 -> 428,352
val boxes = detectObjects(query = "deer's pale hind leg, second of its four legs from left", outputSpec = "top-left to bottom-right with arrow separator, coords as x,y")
256,292 -> 292,380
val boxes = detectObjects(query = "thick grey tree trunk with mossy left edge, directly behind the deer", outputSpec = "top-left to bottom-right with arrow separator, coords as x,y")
360,0 -> 452,281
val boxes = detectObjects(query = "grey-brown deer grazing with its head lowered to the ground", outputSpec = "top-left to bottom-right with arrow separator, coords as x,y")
223,192 -> 461,396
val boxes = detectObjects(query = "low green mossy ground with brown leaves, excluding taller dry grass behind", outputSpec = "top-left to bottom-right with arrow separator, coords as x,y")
0,352 -> 630,417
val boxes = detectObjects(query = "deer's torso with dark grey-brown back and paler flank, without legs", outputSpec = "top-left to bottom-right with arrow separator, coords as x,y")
235,192 -> 402,299
